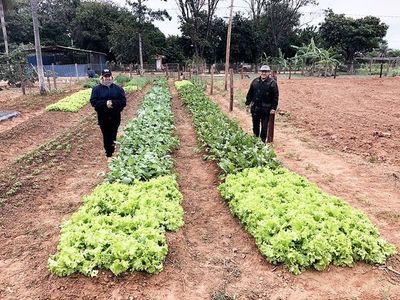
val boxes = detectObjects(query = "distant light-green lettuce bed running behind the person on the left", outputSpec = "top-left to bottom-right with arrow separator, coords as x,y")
46,77 -> 148,112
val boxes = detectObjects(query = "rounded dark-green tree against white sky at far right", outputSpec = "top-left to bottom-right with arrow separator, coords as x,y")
319,9 -> 388,71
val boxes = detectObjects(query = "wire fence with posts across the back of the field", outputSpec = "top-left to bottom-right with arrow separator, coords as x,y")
0,58 -> 400,97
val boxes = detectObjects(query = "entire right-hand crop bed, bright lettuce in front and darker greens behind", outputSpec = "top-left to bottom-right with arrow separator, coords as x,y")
176,82 -> 396,274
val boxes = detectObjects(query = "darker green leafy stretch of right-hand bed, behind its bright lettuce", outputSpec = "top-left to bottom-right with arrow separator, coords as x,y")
175,82 -> 278,174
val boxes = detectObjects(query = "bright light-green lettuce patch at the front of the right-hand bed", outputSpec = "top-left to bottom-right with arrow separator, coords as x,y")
219,168 -> 396,274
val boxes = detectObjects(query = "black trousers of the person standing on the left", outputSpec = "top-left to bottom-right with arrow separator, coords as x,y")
97,114 -> 121,157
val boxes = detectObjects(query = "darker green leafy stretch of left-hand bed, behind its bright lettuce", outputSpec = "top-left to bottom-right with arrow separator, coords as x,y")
108,81 -> 178,184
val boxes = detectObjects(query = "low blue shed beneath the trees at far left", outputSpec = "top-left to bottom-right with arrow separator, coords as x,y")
26,46 -> 107,77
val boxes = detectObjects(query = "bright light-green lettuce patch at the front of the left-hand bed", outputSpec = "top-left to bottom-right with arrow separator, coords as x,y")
48,176 -> 183,276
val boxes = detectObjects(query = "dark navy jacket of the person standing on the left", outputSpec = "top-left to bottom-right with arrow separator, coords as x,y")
90,83 -> 126,115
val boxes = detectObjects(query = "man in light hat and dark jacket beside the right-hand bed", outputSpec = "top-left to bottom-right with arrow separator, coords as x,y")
246,65 -> 279,143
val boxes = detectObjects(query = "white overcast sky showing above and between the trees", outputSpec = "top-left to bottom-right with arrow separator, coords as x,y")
114,0 -> 400,49
